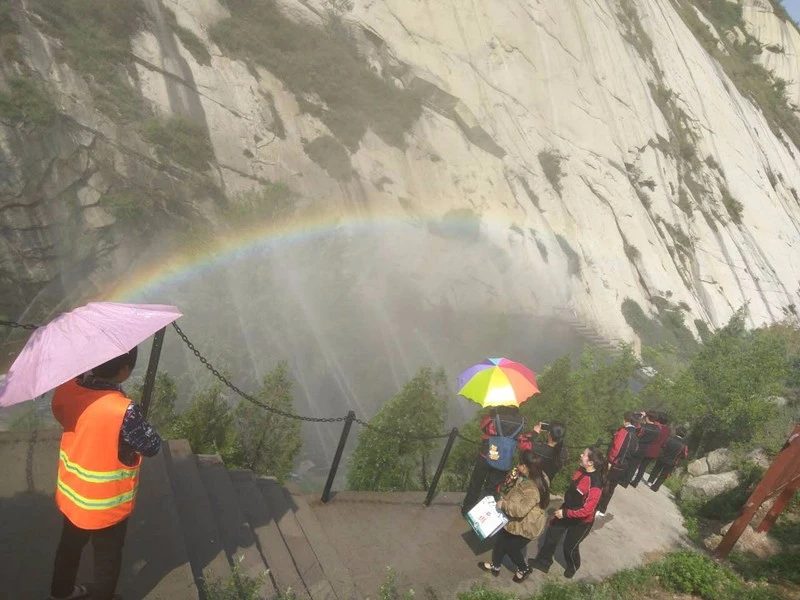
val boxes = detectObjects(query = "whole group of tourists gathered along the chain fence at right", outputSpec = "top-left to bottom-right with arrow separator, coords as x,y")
461,406 -> 688,583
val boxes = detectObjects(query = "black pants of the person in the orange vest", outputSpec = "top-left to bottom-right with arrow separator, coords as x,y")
50,517 -> 128,600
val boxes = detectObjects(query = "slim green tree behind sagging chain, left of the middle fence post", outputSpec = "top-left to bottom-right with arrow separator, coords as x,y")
234,361 -> 302,482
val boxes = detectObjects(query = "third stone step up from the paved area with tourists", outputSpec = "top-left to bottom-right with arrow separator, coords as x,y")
229,469 -> 309,600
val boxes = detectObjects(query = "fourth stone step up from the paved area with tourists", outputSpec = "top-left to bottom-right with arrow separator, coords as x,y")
197,454 -> 277,598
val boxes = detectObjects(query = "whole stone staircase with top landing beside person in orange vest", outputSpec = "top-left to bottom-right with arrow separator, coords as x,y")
0,431 -> 358,600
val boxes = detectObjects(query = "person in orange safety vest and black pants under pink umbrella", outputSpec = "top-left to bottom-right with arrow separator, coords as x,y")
50,348 -> 161,600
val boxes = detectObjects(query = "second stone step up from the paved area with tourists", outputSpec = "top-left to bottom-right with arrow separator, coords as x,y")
257,477 -> 336,600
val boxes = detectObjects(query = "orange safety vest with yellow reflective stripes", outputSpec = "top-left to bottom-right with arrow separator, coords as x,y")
53,380 -> 142,530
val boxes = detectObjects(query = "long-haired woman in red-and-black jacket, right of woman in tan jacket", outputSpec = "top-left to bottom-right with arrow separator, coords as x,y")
528,446 -> 608,579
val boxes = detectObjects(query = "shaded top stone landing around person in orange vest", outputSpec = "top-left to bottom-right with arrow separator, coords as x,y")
0,431 -> 197,600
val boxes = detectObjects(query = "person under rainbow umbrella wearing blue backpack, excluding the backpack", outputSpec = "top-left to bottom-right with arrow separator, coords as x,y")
461,406 -> 526,516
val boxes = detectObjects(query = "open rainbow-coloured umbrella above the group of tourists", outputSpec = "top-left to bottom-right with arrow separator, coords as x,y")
458,358 -> 539,407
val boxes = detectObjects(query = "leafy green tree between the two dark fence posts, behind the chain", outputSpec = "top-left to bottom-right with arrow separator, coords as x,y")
347,367 -> 447,491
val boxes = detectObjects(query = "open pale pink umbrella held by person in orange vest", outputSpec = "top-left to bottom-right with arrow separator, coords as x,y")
0,302 -> 182,407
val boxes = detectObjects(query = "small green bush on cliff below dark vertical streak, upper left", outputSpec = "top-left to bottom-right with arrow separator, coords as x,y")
142,117 -> 214,171
